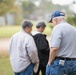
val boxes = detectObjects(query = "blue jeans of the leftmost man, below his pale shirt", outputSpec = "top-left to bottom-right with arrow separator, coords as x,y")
14,64 -> 34,75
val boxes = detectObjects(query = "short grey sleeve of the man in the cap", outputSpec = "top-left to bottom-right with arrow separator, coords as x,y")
50,27 -> 62,48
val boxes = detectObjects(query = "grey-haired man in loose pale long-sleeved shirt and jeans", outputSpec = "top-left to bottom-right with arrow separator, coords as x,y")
9,21 -> 39,75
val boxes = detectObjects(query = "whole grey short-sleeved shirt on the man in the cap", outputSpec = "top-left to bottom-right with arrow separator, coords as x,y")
50,21 -> 76,58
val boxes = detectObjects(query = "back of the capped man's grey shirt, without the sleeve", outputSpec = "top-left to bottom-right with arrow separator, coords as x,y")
50,22 -> 76,58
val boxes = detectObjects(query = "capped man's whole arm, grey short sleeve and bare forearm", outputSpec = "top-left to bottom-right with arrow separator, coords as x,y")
49,26 -> 62,64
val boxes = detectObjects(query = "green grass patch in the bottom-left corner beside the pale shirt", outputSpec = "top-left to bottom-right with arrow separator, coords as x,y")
0,57 -> 14,75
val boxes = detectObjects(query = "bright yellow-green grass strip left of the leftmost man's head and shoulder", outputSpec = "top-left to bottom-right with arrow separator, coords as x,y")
0,26 -> 21,38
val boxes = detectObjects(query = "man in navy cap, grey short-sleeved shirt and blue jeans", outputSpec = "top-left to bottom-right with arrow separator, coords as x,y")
46,11 -> 76,75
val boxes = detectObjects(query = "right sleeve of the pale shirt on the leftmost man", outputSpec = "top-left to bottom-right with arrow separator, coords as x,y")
26,37 -> 39,63
